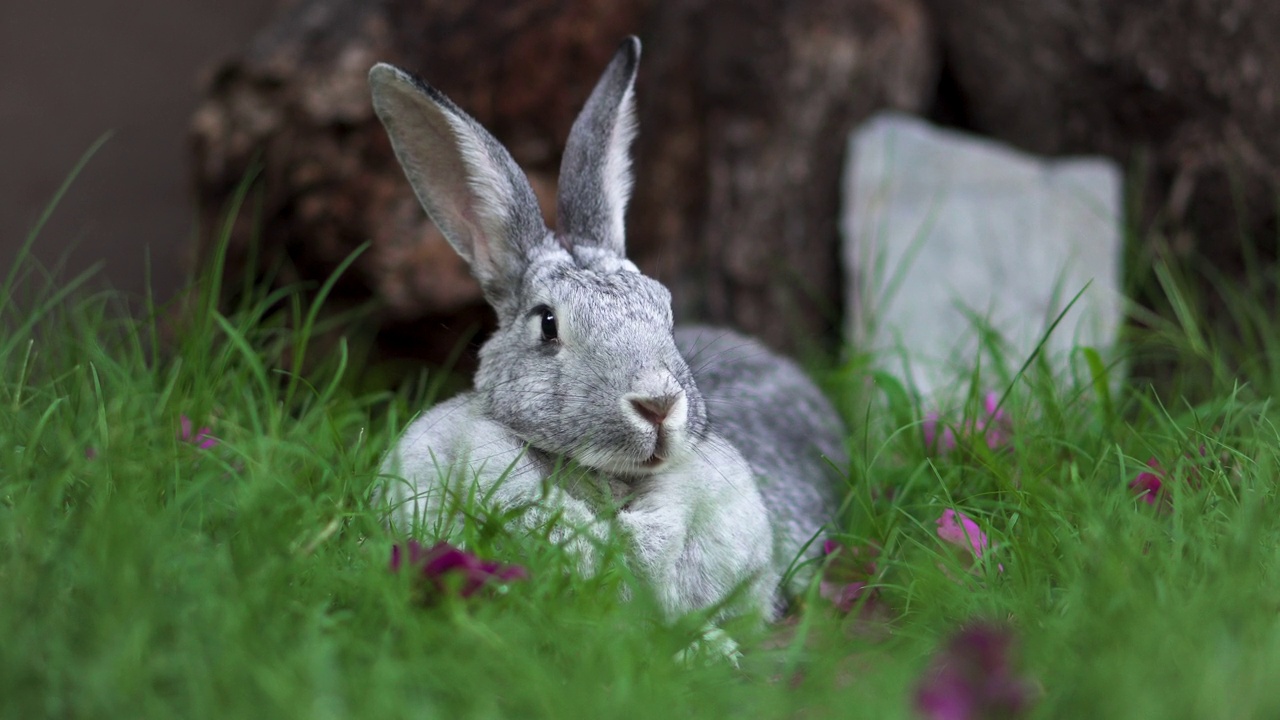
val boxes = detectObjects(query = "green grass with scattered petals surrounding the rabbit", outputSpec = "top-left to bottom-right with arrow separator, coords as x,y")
0,174 -> 1280,719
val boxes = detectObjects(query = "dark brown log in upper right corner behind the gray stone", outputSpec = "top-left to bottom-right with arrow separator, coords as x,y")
928,0 -> 1280,268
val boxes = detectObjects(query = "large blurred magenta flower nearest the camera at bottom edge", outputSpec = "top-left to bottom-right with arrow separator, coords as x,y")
915,624 -> 1033,720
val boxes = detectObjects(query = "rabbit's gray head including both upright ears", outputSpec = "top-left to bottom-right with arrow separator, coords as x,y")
369,37 -> 707,477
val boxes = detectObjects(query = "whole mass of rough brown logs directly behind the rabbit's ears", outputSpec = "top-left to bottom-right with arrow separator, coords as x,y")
192,0 -> 934,361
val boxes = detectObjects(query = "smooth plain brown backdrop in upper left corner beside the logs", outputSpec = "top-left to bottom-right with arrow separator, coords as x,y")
0,0 -> 274,296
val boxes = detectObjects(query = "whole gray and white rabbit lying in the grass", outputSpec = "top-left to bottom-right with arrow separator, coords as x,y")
369,37 -> 846,619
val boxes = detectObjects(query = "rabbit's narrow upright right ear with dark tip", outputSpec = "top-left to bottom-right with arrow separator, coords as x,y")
558,37 -> 640,256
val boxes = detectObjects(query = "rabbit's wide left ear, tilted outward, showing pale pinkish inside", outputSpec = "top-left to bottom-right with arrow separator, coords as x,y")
369,63 -> 548,305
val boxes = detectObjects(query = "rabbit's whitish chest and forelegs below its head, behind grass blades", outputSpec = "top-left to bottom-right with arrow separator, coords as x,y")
383,393 -> 778,618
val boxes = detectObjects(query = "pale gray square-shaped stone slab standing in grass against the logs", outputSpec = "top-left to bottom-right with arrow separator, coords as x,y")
842,114 -> 1123,402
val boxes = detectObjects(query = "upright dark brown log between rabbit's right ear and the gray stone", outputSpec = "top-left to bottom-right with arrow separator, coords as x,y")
632,0 -> 936,352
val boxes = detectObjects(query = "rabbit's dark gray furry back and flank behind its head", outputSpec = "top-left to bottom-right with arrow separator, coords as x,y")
675,325 -> 847,571
